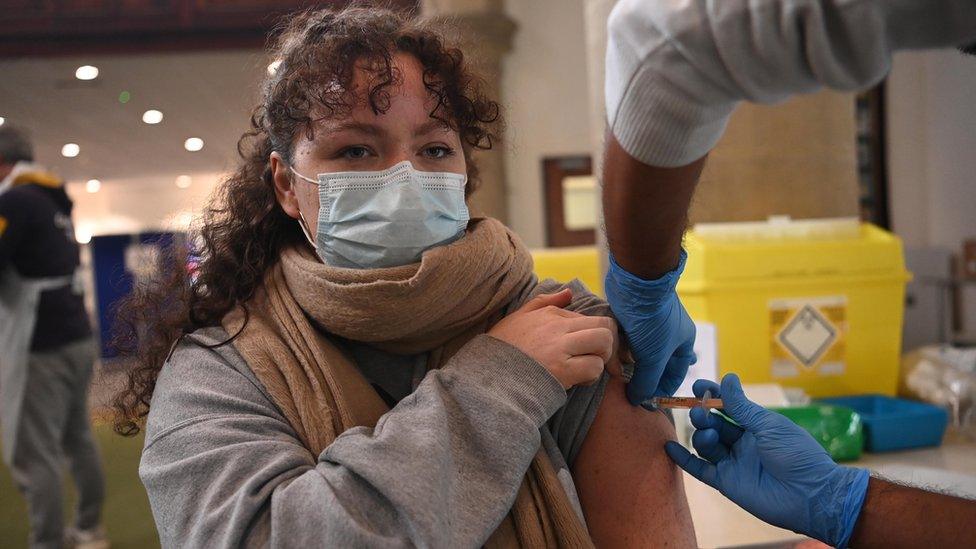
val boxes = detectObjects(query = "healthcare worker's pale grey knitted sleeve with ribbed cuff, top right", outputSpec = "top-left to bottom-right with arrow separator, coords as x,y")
606,0 -> 976,167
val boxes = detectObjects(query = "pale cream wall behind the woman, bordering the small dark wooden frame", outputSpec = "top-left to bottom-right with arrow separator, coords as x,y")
502,0 -> 591,247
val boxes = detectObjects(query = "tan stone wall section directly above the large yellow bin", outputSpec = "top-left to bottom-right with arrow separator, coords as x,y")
689,91 -> 858,223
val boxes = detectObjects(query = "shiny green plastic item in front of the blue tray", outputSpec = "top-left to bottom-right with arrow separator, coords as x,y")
770,404 -> 864,461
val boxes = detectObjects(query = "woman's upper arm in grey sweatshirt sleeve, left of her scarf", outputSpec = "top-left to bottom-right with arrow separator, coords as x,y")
139,341 -> 316,547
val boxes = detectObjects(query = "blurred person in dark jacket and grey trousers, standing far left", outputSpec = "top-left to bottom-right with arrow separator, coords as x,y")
0,126 -> 108,548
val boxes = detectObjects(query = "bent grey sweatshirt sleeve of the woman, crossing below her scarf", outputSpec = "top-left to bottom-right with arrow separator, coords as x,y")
139,333 -> 566,547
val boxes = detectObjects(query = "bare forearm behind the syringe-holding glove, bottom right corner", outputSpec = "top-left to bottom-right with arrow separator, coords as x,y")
850,478 -> 976,547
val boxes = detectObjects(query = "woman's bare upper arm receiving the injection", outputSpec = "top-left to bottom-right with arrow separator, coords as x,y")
573,377 -> 696,547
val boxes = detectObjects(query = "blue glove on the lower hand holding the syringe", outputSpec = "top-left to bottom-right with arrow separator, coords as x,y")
665,374 -> 869,547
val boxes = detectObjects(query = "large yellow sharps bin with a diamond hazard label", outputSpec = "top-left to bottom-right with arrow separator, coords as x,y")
678,220 -> 910,397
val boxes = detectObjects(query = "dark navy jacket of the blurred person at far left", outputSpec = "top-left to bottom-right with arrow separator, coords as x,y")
0,182 -> 92,351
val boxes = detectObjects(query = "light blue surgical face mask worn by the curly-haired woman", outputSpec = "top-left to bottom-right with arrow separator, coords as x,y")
292,161 -> 470,269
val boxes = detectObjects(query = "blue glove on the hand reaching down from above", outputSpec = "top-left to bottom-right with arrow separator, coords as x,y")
604,250 -> 696,406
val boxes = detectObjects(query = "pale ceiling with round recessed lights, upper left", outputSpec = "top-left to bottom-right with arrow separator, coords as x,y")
0,50 -> 269,181
